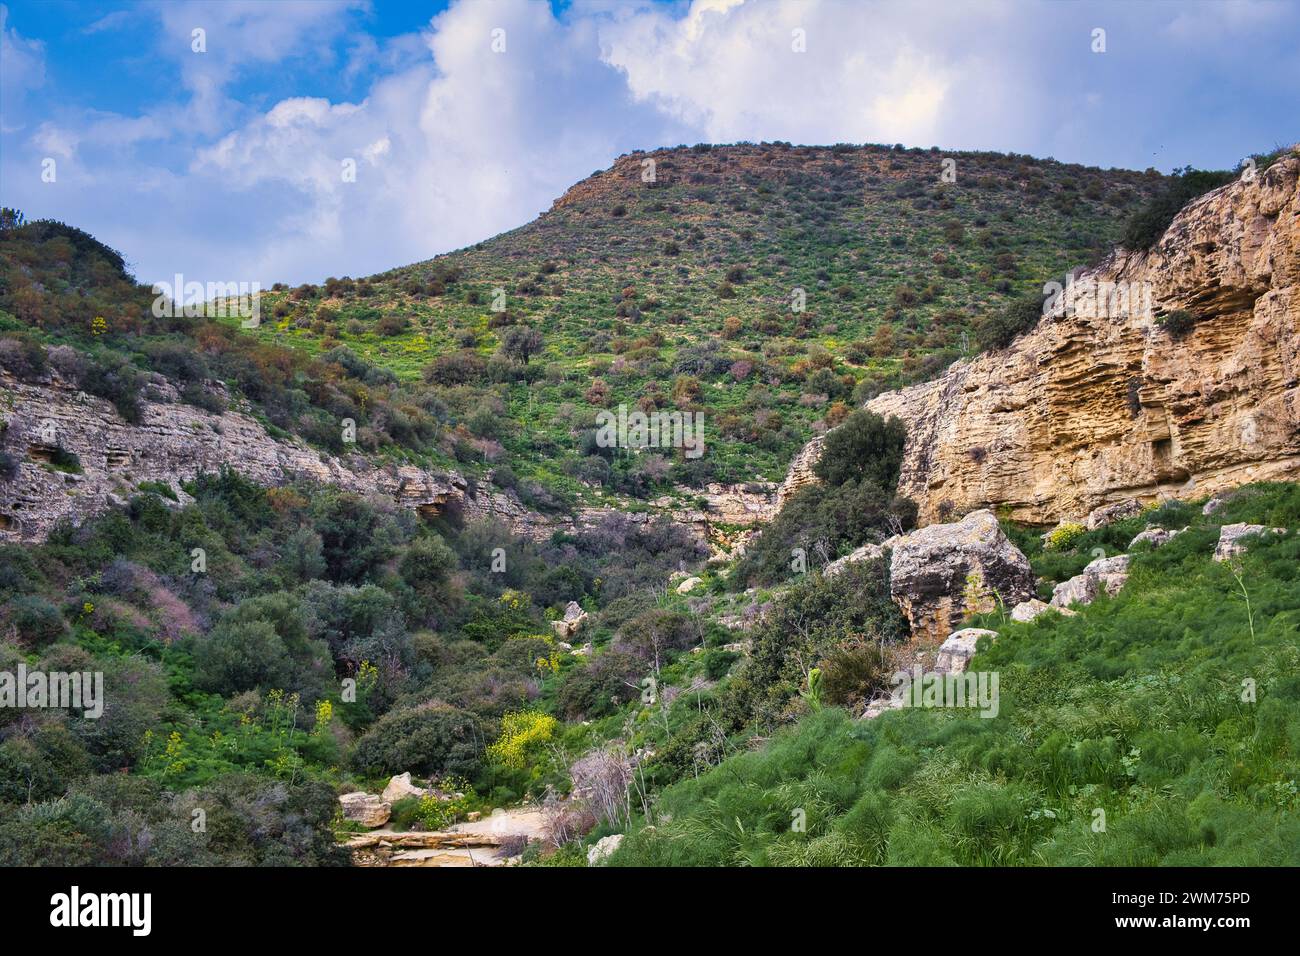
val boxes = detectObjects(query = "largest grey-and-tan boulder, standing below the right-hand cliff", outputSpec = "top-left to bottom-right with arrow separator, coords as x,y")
889,510 -> 1034,644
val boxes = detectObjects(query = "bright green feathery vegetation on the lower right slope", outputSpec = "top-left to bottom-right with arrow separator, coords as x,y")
614,484 -> 1300,866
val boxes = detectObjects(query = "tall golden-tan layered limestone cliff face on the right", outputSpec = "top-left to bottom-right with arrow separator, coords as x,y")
781,155 -> 1300,524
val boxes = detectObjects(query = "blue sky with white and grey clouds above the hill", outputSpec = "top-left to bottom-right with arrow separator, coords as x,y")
0,0 -> 1300,286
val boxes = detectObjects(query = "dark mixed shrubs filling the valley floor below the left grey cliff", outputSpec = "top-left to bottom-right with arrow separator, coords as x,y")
0,472 -> 699,865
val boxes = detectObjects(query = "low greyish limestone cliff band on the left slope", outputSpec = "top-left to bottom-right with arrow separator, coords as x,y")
0,376 -> 553,541
